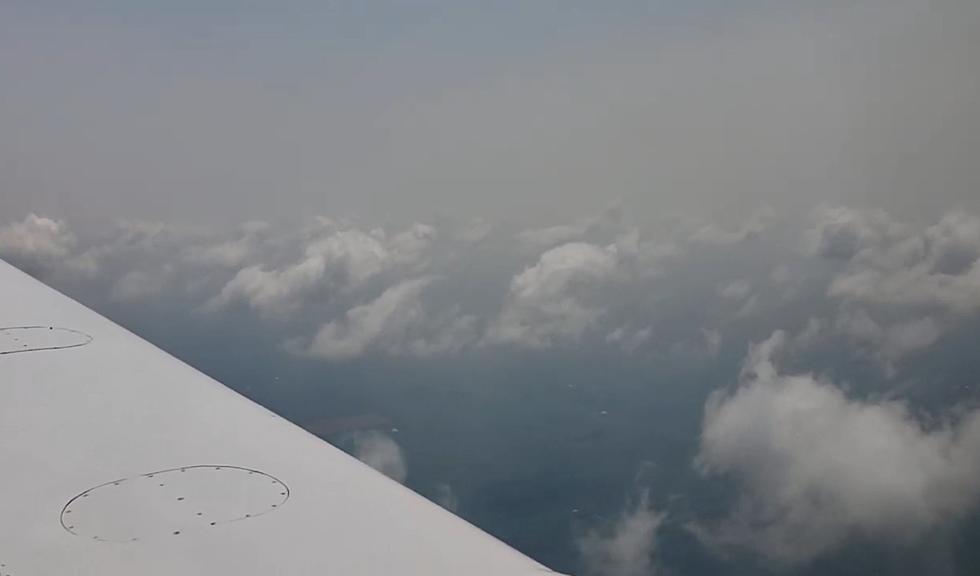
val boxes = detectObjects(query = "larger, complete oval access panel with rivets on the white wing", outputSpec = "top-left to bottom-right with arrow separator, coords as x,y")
61,466 -> 289,542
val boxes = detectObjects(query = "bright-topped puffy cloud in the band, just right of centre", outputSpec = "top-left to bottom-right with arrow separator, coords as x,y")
502,202 -> 681,353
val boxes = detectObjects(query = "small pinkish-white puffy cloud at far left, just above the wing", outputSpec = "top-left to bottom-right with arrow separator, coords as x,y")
0,214 -> 75,264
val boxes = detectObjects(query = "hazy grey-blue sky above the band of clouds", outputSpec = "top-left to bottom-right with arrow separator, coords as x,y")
0,0 -> 980,226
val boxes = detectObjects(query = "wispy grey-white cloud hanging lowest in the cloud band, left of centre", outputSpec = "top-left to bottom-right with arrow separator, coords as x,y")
306,277 -> 475,360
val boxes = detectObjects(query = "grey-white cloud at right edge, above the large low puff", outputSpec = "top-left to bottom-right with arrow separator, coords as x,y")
806,207 -> 980,376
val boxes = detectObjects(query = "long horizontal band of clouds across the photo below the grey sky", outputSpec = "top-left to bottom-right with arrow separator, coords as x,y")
7,205 -> 980,376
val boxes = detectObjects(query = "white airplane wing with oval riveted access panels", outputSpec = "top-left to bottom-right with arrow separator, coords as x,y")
0,261 -> 568,576
